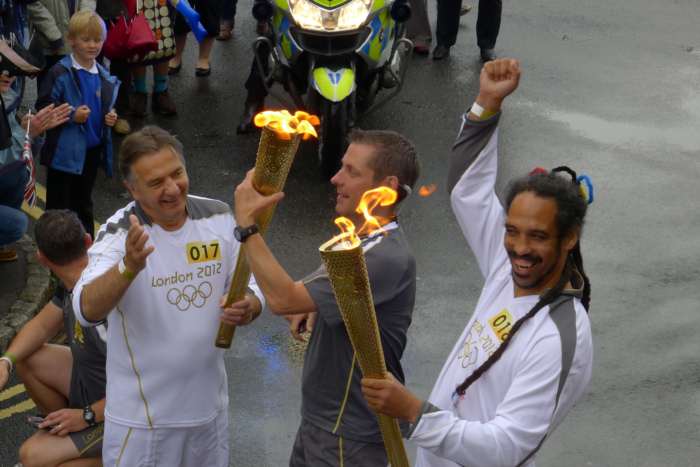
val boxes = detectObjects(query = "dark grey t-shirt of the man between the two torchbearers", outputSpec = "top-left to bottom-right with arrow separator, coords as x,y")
301,228 -> 416,443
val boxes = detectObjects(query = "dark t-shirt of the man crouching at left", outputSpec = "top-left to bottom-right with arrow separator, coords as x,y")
51,286 -> 107,408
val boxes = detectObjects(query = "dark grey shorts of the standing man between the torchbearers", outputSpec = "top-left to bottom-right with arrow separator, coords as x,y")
289,420 -> 389,467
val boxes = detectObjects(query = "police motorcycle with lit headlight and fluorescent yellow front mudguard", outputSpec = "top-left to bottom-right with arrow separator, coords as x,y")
253,0 -> 413,178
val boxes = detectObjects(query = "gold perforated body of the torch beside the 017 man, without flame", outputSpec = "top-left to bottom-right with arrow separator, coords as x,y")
215,127 -> 301,349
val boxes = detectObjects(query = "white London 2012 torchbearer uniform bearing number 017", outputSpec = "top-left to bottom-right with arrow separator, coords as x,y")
73,195 -> 264,467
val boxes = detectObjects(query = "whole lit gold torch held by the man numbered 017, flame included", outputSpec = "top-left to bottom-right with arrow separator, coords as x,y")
215,110 -> 319,349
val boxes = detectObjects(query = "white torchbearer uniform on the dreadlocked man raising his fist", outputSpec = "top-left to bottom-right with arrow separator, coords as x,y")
409,116 -> 593,467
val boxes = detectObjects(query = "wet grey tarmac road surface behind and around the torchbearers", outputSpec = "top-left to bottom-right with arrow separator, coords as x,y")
0,0 -> 700,467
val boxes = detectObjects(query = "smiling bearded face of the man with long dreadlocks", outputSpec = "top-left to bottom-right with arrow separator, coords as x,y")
504,191 -> 578,296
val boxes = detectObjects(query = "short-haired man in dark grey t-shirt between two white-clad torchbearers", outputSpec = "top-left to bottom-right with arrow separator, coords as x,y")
224,130 -> 419,467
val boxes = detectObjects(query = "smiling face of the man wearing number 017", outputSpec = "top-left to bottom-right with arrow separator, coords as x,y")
125,146 -> 190,230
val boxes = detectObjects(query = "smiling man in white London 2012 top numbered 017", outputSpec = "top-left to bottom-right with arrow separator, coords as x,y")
73,127 -> 262,467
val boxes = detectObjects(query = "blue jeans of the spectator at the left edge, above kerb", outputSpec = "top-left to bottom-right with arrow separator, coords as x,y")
0,165 -> 29,246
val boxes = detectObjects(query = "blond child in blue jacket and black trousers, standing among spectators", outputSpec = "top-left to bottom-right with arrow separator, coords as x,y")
37,11 -> 120,237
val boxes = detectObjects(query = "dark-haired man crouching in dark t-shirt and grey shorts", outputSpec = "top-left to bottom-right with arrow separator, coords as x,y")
0,211 -> 106,467
